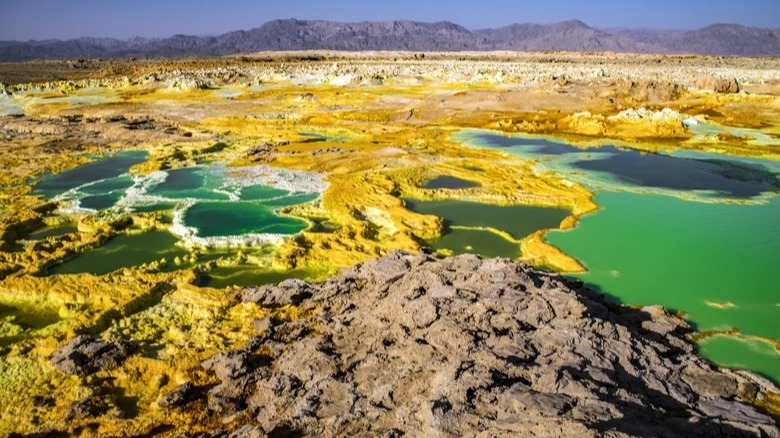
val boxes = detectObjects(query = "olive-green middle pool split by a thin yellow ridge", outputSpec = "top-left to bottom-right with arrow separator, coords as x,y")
403,198 -> 571,258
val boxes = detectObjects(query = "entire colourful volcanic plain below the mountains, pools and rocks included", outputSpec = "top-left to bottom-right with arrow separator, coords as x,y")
0,51 -> 780,437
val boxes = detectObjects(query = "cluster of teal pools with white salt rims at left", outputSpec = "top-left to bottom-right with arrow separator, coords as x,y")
35,155 -> 325,246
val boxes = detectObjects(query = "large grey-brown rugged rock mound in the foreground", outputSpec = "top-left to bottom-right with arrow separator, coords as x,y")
198,252 -> 780,437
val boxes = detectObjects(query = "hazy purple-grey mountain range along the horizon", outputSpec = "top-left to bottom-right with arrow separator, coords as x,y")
0,19 -> 780,61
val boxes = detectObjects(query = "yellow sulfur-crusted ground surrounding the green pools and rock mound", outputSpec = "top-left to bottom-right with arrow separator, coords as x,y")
0,53 -> 780,435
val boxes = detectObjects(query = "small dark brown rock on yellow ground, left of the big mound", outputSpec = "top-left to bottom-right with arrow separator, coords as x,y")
51,335 -> 134,376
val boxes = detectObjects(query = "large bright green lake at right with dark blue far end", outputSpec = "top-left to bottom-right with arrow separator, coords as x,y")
457,131 -> 780,382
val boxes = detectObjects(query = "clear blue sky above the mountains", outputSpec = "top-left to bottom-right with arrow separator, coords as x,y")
0,0 -> 780,40
